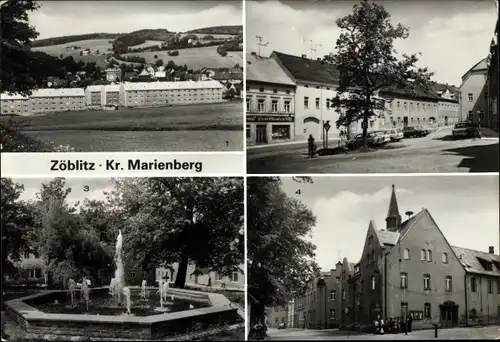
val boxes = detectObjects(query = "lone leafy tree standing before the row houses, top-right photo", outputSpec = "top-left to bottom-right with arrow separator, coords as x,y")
327,0 -> 432,147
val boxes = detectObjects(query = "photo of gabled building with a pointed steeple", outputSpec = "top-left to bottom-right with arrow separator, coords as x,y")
247,175 -> 500,341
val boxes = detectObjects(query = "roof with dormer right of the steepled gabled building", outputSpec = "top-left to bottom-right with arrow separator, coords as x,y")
451,246 -> 500,277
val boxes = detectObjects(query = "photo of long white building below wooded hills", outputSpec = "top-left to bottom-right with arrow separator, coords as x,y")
0,0 -> 244,152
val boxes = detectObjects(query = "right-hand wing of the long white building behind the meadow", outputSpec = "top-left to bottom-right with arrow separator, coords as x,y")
120,81 -> 223,107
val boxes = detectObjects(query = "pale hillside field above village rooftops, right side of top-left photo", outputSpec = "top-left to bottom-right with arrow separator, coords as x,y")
123,46 -> 243,69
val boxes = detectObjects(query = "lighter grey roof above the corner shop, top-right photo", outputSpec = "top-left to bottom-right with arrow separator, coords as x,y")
246,55 -> 295,86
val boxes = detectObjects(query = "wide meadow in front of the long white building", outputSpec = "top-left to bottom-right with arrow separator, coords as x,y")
0,102 -> 243,152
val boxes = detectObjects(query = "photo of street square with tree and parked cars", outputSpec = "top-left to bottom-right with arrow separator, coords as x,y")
245,0 -> 499,174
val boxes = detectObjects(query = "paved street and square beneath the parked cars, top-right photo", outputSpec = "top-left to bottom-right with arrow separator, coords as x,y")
247,127 -> 499,174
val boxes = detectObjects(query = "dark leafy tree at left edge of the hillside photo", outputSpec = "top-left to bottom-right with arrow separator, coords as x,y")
0,0 -> 39,95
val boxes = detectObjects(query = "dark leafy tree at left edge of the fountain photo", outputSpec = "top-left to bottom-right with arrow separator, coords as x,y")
0,178 -> 33,281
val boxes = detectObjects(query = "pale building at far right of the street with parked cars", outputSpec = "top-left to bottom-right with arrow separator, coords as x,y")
459,58 -> 488,122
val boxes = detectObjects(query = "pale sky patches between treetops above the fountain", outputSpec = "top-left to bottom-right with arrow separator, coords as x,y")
12,178 -> 114,204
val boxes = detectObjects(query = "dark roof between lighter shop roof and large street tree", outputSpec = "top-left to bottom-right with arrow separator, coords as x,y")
271,51 -> 339,85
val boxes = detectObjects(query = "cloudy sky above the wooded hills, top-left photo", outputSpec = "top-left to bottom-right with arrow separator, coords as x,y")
29,0 -> 243,39
